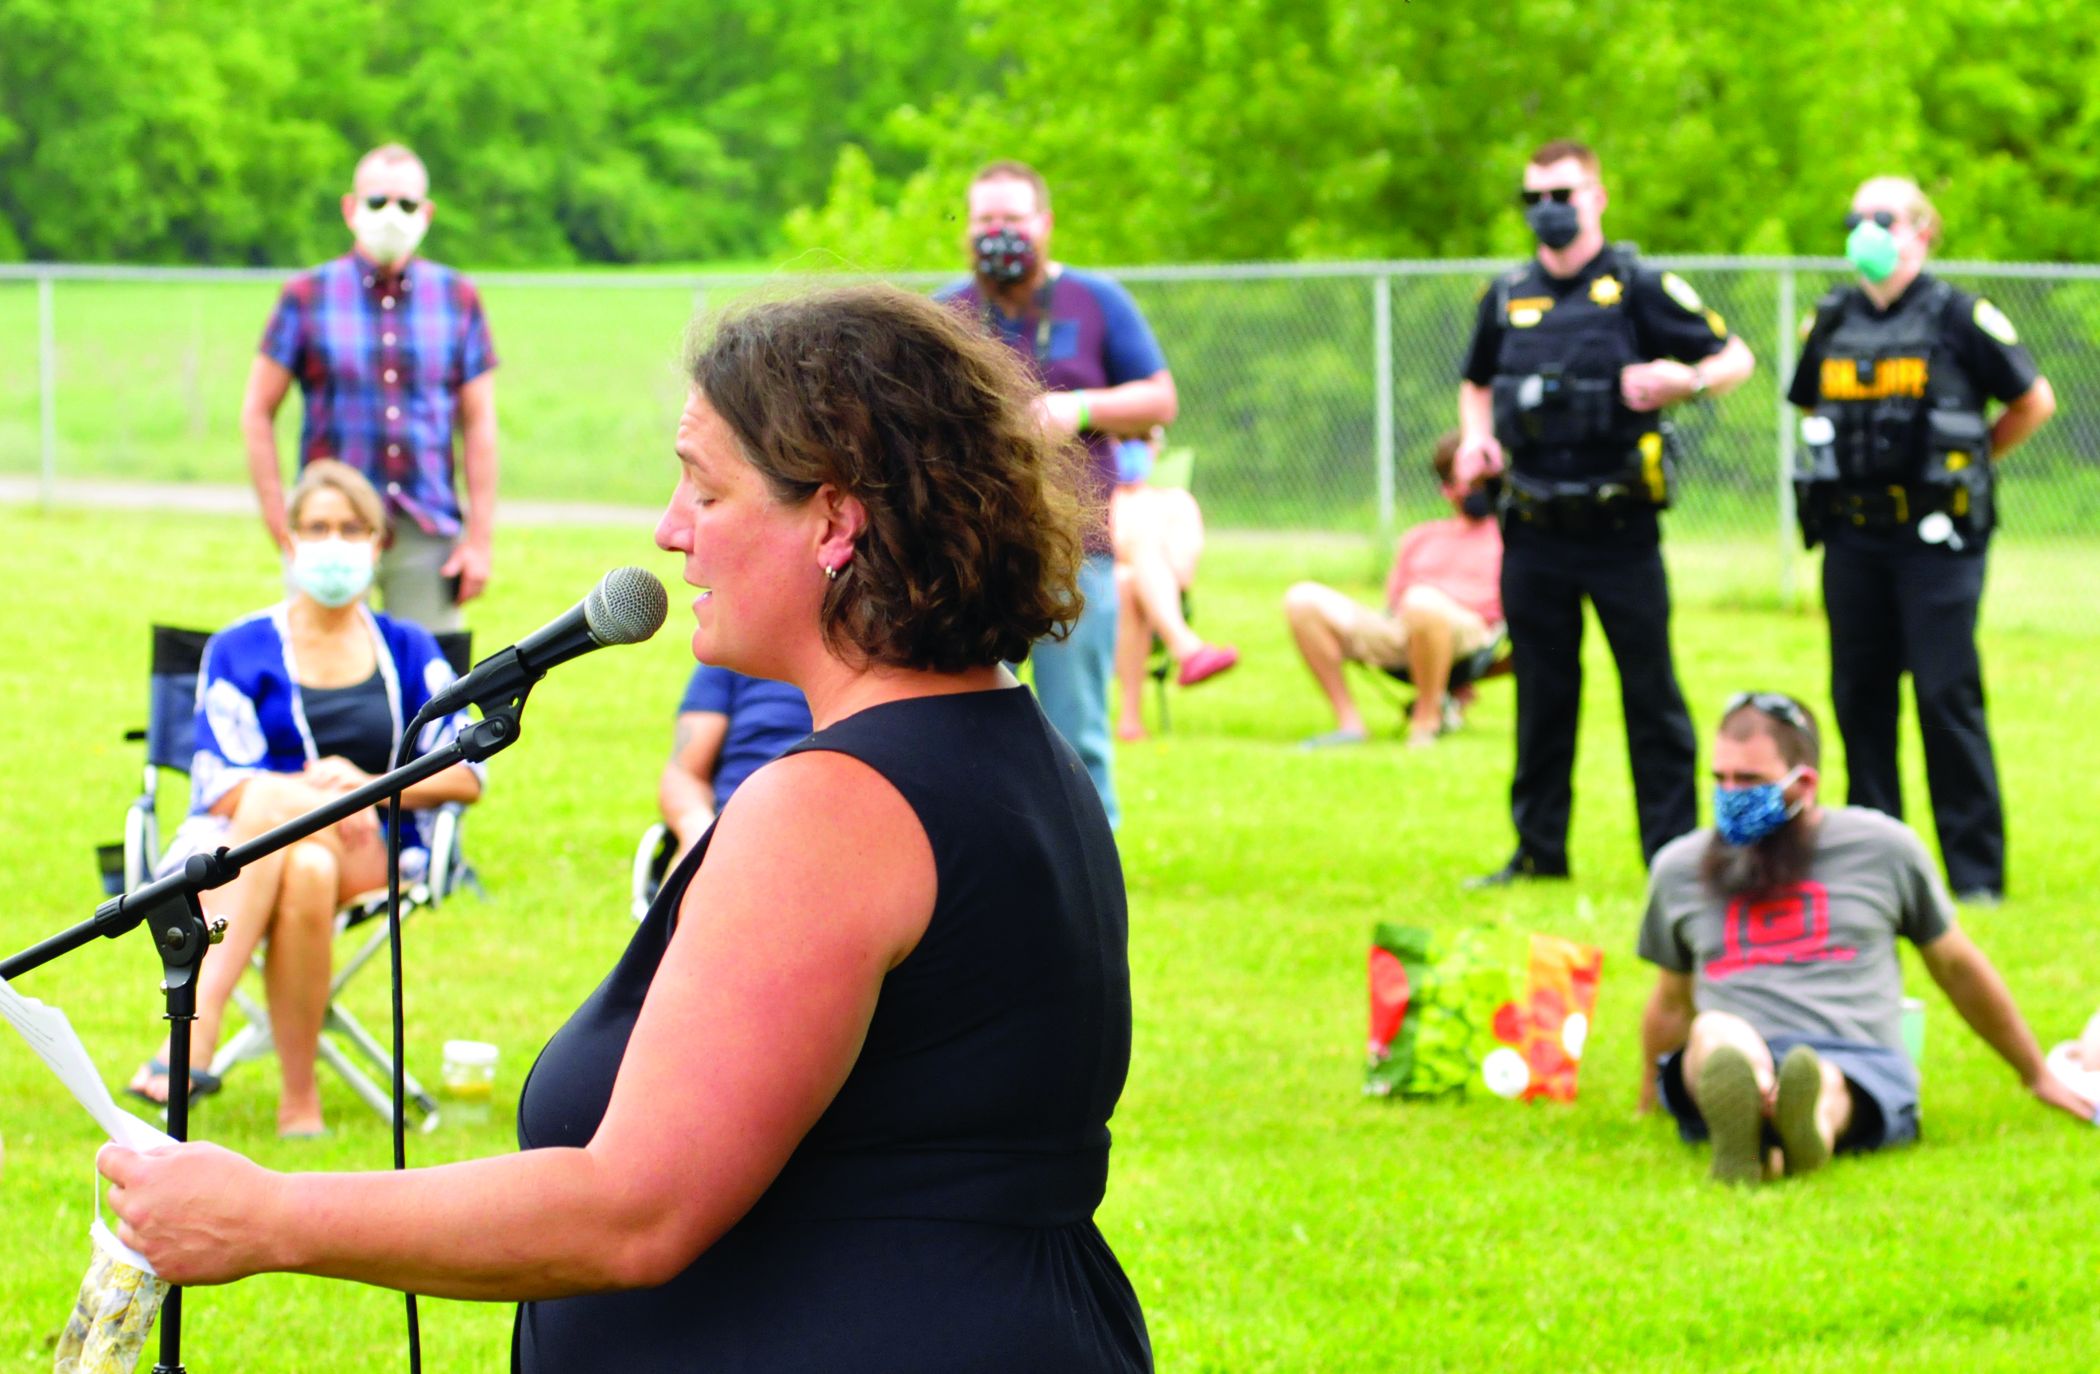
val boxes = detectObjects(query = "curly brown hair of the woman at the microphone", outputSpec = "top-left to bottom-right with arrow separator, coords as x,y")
689,286 -> 1094,672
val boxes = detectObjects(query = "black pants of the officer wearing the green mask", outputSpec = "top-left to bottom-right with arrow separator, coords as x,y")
1823,533 -> 2006,893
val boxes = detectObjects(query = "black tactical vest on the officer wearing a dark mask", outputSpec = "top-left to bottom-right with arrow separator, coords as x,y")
1493,248 -> 1667,489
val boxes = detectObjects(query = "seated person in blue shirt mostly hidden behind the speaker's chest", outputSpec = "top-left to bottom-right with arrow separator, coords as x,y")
657,664 -> 811,855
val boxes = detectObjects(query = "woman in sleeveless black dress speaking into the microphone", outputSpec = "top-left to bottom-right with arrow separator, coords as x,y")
101,288 -> 1151,1374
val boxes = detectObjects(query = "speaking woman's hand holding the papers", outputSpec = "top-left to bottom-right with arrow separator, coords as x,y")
95,1143 -> 284,1286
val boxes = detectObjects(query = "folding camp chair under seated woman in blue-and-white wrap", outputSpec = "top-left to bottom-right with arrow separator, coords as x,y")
97,626 -> 479,1130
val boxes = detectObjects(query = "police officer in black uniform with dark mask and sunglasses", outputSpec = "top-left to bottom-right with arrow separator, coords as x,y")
1455,141 -> 1754,884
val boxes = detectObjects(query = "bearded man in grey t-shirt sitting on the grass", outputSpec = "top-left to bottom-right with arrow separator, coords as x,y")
1640,691 -> 2094,1183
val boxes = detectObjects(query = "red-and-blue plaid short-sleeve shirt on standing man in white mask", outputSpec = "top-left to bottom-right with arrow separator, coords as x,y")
263,252 -> 496,536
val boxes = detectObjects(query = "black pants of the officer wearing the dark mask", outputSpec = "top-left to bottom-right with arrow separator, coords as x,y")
1502,529 -> 1699,870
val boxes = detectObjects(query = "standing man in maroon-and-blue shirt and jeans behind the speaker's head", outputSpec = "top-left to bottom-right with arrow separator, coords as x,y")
941,162 -> 1178,826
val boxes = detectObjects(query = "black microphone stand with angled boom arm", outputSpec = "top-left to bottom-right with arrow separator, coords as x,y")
0,701 -> 531,1374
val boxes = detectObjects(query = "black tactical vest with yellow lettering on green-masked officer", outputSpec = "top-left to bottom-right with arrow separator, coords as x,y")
1814,277 -> 1991,485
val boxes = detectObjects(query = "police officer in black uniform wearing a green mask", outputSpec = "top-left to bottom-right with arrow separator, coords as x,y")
1787,176 -> 2056,903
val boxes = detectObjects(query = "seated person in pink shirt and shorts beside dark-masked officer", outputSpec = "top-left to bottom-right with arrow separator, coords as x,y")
1283,431 -> 1502,748
